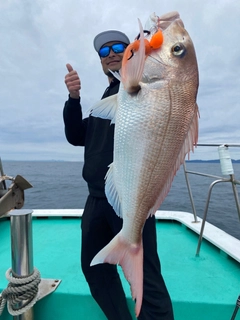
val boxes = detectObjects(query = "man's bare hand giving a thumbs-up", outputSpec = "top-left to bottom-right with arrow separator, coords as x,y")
65,63 -> 81,99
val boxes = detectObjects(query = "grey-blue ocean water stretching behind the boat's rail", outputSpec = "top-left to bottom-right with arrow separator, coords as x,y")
2,161 -> 240,239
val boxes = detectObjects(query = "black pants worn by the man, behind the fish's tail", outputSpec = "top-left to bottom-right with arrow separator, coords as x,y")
81,196 -> 174,320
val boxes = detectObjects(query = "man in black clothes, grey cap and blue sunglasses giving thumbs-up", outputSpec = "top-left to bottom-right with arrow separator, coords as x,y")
63,30 -> 173,320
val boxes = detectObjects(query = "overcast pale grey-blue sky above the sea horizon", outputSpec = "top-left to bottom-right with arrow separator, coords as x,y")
0,0 -> 240,161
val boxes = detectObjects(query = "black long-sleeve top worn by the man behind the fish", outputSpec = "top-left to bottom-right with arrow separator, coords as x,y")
63,79 -> 119,197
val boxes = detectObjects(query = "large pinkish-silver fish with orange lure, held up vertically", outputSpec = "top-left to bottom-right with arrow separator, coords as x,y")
91,12 -> 199,316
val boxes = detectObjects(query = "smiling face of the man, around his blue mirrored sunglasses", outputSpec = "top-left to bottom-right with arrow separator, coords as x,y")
100,41 -> 124,77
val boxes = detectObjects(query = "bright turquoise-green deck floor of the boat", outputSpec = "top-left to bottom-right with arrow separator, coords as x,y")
0,218 -> 240,320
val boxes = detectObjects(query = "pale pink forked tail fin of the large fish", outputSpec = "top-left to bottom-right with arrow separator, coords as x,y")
90,232 -> 143,317
